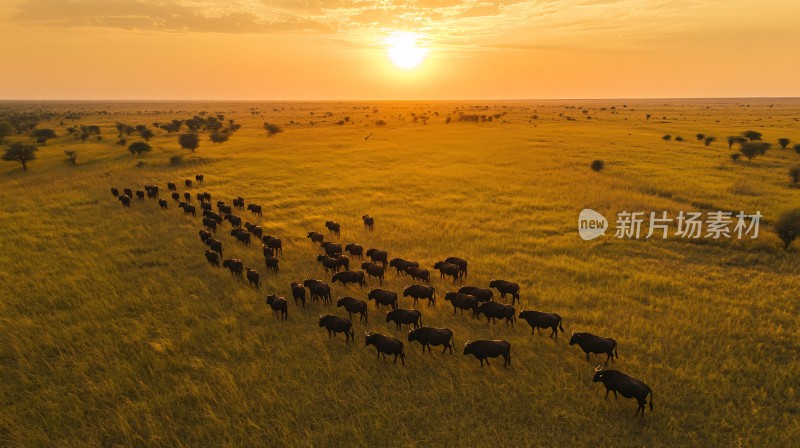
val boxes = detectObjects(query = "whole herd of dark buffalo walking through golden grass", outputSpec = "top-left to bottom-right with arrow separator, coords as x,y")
111,174 -> 653,416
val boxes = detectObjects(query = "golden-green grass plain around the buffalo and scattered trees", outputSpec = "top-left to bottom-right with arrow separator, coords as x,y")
0,99 -> 800,447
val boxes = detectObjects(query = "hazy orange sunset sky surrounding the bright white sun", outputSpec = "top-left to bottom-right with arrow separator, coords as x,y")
0,0 -> 800,100
